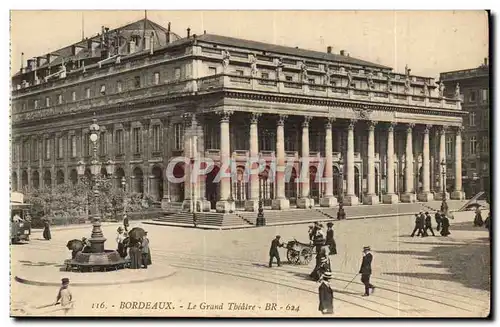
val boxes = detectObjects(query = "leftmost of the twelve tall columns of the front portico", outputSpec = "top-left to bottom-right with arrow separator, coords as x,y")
216,110 -> 235,213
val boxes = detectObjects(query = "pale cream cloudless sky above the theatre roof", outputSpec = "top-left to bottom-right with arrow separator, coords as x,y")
11,10 -> 489,78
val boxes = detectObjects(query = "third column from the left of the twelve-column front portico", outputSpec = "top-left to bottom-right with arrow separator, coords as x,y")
271,115 -> 290,210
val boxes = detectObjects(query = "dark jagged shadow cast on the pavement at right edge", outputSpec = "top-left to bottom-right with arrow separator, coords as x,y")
377,238 -> 491,291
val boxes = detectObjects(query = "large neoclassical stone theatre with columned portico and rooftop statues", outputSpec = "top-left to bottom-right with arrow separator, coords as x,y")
11,19 -> 466,212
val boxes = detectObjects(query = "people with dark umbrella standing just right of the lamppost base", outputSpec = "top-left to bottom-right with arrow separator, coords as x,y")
116,226 -> 152,269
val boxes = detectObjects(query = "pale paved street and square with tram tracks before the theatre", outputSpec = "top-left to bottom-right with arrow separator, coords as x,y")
11,213 -> 490,317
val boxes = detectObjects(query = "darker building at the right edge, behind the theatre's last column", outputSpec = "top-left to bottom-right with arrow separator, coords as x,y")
440,58 -> 491,197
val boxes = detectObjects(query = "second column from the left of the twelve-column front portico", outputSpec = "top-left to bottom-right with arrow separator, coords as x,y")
245,113 -> 261,211
